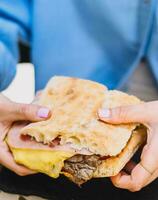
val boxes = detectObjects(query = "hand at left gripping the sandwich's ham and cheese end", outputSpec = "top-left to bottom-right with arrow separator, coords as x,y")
0,94 -> 51,176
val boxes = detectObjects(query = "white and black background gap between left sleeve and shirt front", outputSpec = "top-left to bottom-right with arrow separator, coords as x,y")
3,44 -> 34,103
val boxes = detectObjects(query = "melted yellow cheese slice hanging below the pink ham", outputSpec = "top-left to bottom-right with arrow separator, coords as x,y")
11,147 -> 74,178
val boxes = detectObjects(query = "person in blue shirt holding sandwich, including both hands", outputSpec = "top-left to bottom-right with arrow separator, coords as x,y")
0,0 -> 158,191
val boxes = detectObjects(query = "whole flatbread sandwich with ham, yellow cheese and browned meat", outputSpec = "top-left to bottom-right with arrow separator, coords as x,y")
6,76 -> 146,185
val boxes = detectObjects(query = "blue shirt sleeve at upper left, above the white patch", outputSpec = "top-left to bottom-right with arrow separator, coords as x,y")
0,0 -> 31,91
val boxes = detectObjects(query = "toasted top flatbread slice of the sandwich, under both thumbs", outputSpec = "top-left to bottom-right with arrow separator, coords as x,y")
21,76 -> 141,156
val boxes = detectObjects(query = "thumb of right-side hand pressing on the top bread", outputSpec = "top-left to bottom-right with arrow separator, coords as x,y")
98,101 -> 158,124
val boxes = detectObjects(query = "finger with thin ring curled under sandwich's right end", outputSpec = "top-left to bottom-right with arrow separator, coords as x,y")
111,134 -> 158,191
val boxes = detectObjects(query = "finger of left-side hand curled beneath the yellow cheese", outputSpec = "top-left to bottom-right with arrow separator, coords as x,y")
0,145 -> 36,176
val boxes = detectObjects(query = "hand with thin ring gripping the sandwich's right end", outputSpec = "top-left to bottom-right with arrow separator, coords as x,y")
98,101 -> 158,191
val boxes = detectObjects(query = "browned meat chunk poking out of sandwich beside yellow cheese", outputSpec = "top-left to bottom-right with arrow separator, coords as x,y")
63,155 -> 102,185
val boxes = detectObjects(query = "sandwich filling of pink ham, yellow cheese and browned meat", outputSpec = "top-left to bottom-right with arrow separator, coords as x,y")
7,126 -> 139,185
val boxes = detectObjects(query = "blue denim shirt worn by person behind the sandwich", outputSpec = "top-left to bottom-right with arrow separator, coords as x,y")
0,0 -> 158,90
